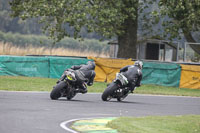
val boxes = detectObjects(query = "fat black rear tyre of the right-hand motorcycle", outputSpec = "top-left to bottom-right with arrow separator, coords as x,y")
101,82 -> 118,101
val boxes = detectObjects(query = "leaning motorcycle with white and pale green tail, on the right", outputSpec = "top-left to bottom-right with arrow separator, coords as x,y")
101,73 -> 133,101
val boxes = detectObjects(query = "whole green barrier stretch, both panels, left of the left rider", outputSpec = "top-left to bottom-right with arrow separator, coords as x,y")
0,56 -> 89,78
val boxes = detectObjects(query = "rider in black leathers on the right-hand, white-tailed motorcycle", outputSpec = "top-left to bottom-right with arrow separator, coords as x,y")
120,61 -> 143,93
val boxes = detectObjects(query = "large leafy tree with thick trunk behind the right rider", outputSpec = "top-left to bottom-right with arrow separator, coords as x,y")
10,0 -> 139,58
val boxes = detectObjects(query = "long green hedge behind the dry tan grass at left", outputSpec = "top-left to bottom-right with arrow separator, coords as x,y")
0,32 -> 110,53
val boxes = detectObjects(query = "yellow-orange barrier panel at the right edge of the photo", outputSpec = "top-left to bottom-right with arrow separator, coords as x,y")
180,65 -> 200,89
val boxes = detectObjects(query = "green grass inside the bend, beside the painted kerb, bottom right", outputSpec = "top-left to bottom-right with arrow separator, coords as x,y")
106,115 -> 200,133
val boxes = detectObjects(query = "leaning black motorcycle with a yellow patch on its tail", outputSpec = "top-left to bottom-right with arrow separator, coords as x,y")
50,71 -> 87,100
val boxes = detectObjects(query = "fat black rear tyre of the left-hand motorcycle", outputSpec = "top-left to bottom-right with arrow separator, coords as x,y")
50,81 -> 67,100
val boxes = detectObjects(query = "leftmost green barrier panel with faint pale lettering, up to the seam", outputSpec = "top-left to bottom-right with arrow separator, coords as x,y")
0,56 -> 49,77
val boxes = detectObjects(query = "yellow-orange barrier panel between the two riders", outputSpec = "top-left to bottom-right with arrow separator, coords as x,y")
88,57 -> 134,83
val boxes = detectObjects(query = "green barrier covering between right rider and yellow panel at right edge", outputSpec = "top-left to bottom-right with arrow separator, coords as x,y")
142,62 -> 181,87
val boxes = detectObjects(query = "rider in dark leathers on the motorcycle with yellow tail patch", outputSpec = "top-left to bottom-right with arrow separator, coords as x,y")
57,61 -> 96,93
